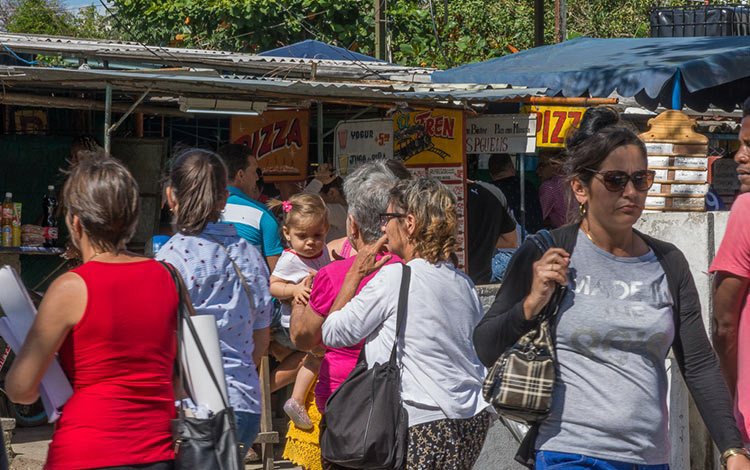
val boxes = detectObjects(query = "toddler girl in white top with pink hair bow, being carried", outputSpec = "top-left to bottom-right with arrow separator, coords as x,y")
269,193 -> 331,429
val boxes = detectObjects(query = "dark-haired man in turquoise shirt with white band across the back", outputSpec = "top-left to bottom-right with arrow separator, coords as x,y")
219,144 -> 284,272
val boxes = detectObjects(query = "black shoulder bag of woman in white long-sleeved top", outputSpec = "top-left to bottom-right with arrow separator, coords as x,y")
320,265 -> 411,470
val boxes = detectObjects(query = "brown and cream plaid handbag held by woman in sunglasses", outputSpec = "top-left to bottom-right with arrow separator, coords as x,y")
482,230 -> 567,424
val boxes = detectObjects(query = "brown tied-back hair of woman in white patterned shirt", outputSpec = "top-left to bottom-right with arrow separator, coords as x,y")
168,149 -> 227,235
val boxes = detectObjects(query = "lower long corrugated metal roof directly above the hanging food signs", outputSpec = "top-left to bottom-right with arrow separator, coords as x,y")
0,67 -> 545,106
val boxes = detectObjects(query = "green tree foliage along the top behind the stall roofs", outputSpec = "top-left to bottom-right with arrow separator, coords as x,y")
0,0 -> 748,68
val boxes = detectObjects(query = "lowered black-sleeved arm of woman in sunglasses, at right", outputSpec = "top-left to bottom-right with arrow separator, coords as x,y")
667,252 -> 742,452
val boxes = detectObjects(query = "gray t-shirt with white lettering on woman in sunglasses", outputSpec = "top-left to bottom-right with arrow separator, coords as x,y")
536,231 -> 675,465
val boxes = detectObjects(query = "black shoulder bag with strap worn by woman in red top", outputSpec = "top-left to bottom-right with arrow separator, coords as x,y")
162,263 -> 245,470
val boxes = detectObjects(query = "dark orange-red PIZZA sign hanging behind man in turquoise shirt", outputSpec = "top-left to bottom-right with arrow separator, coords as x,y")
230,111 -> 310,182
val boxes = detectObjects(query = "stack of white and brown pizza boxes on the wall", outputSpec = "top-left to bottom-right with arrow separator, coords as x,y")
640,110 -> 708,212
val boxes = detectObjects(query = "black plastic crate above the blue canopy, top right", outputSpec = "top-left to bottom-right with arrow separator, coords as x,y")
651,5 -> 750,37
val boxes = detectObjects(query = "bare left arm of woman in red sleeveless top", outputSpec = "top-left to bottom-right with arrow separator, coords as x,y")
5,273 -> 87,404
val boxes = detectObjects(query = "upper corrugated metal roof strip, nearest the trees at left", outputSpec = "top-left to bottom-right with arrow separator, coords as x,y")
0,33 -> 432,82
